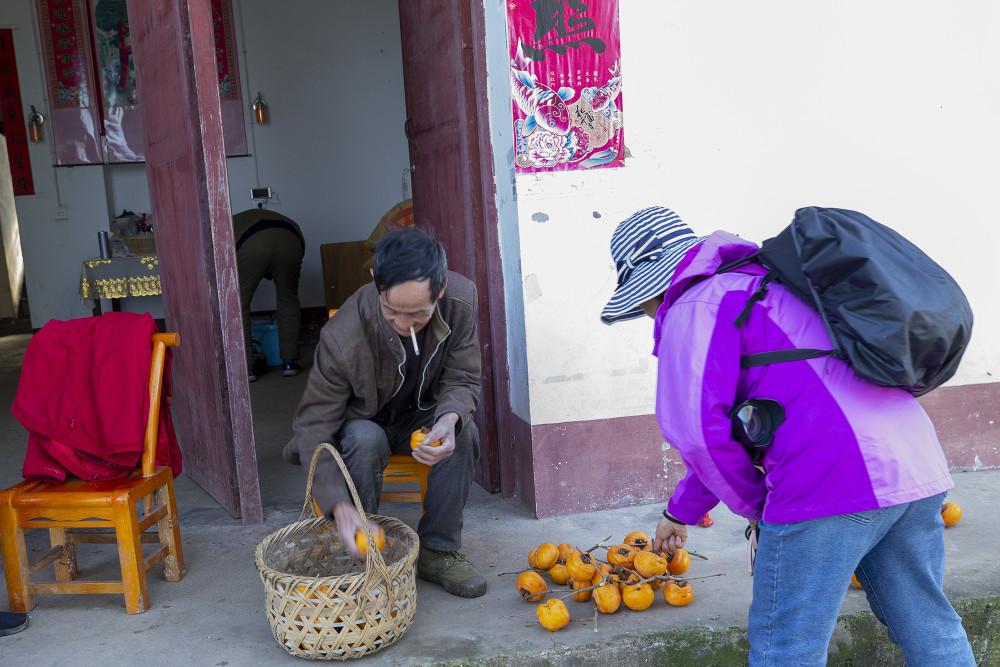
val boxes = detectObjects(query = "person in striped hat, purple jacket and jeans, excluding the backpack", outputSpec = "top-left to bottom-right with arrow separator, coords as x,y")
601,207 -> 975,667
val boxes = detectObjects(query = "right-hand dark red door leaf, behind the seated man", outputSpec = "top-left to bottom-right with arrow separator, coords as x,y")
399,0 -> 530,496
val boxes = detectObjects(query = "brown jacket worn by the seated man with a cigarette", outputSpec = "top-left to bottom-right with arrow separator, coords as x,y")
284,271 -> 482,511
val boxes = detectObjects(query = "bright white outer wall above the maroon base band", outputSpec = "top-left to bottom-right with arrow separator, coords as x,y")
517,0 -> 1000,424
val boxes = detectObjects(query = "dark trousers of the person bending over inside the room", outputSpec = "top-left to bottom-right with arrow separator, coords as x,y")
236,229 -> 303,364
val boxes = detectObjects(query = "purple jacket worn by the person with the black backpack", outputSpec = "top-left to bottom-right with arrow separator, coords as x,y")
653,232 -> 954,524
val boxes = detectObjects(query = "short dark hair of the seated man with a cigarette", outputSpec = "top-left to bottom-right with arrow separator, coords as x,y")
374,227 -> 448,301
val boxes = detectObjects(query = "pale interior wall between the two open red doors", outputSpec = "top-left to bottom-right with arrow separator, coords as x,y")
229,0 -> 410,310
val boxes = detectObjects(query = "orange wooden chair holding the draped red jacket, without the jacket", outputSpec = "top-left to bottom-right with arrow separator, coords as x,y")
0,333 -> 184,614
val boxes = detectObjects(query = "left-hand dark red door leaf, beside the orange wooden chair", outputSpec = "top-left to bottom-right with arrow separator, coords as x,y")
126,0 -> 264,524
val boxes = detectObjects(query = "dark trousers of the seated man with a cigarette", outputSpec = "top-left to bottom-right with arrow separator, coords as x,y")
337,410 -> 479,551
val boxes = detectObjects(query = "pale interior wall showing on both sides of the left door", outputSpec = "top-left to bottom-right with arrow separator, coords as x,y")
7,0 -> 409,327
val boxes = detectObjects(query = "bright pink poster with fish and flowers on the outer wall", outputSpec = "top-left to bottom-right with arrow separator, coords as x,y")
507,0 -> 625,172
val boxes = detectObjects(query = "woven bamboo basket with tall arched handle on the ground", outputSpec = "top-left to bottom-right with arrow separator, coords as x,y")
254,443 -> 419,660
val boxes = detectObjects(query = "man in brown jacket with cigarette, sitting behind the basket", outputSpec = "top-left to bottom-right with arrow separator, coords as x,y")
284,228 -> 486,597
